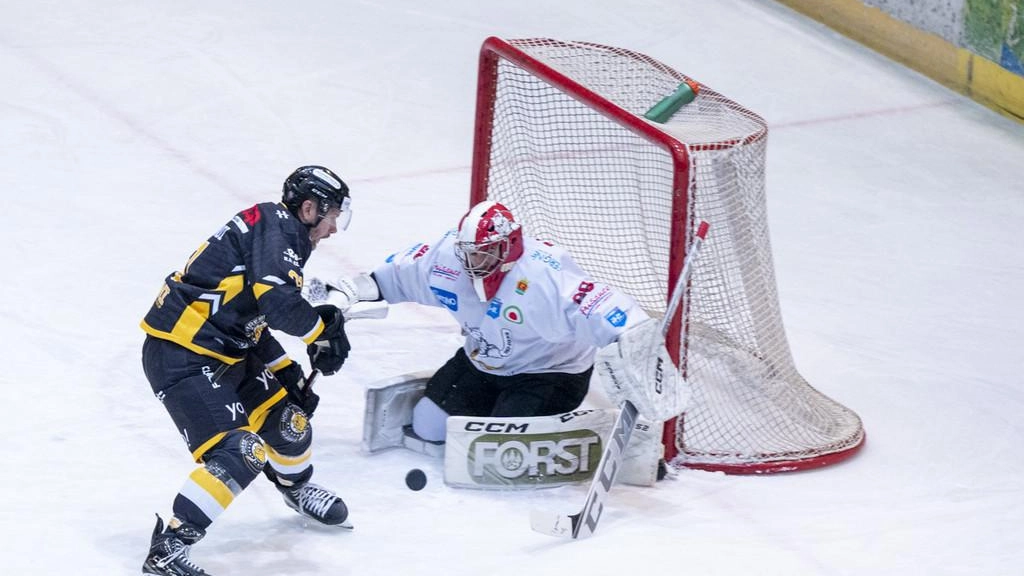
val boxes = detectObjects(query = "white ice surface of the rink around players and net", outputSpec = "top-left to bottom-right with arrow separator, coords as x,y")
0,0 -> 1024,576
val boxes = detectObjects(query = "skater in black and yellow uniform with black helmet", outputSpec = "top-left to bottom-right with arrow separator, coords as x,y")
141,166 -> 351,576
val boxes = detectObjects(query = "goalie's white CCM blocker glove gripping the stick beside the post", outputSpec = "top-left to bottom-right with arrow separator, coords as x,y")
594,319 -> 690,422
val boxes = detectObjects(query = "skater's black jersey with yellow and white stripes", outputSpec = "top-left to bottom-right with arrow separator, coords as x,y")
141,202 -> 324,364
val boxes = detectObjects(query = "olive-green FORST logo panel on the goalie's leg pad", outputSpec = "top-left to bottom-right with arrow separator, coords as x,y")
466,429 -> 602,485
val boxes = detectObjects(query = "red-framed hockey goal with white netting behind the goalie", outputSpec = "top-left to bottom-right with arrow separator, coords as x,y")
471,38 -> 864,472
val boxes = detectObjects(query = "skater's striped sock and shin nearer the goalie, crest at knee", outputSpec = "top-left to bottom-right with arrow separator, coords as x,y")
259,402 -> 313,486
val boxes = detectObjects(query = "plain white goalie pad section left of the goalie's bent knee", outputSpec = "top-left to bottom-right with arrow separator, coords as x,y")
362,370 -> 433,454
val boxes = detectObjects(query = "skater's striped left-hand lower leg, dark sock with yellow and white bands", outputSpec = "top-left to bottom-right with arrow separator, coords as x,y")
173,429 -> 266,530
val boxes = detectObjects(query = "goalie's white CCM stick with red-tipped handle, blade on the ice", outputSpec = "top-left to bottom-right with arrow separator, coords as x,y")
529,220 -> 709,539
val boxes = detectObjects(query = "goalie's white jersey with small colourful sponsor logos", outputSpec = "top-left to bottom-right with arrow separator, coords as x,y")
374,231 -> 647,376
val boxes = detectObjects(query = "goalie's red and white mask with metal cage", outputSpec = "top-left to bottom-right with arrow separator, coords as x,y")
455,200 -> 522,301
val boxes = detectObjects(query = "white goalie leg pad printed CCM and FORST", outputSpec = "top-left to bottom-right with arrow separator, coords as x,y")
444,410 -> 616,490
